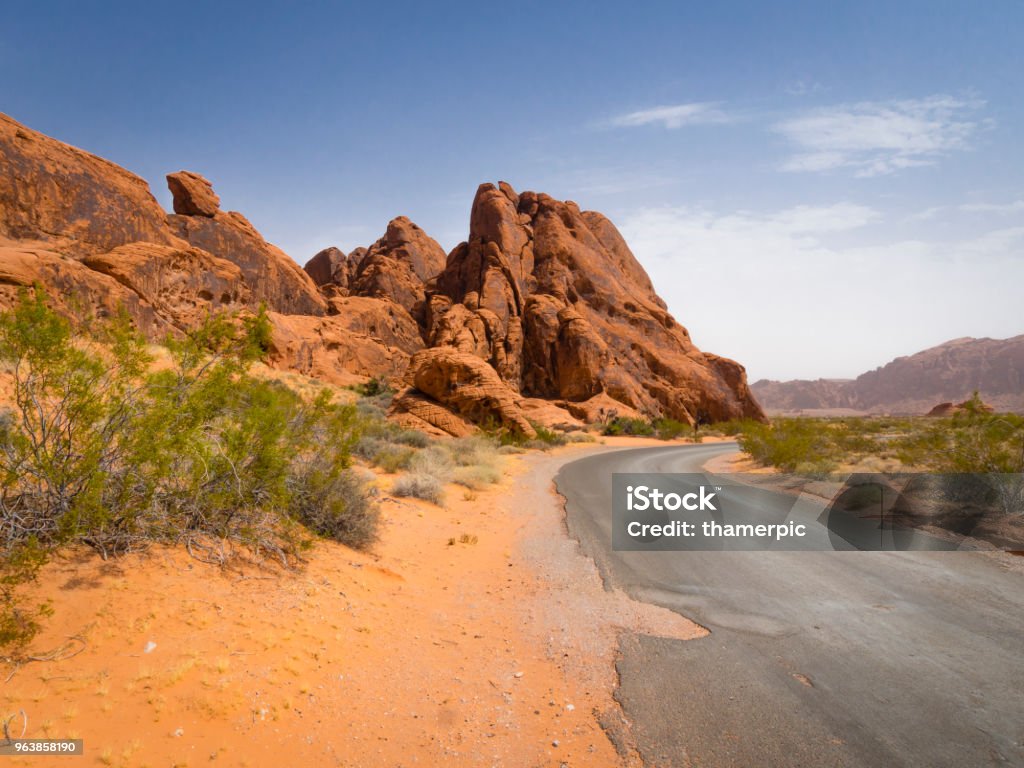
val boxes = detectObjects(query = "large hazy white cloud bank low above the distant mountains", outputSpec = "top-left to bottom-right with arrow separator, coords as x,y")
620,203 -> 1024,380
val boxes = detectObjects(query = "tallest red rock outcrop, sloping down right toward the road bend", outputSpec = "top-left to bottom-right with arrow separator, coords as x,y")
426,183 -> 763,424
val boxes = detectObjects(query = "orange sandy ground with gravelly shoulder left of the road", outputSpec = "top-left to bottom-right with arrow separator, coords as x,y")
0,438 -> 705,767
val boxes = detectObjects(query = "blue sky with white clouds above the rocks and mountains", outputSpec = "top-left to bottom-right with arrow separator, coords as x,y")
0,0 -> 1024,380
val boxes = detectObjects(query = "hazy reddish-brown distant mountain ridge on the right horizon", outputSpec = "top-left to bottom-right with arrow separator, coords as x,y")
751,335 -> 1024,414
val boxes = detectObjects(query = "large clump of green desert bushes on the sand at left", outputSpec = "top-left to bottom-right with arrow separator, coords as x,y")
0,291 -> 377,647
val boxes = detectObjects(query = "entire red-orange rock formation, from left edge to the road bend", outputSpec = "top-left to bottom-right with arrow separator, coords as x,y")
0,116 -> 763,434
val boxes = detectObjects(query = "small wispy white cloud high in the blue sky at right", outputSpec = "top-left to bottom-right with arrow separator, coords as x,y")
772,95 -> 987,176
